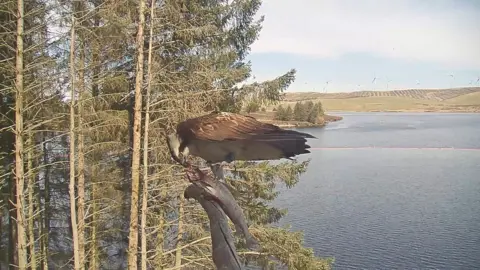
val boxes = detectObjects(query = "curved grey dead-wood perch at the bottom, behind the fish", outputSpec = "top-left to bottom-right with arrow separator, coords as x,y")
183,184 -> 242,270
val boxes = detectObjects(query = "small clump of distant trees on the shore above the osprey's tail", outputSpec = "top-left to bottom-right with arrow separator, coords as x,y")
275,100 -> 324,124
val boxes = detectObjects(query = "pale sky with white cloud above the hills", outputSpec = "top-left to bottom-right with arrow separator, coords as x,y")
248,0 -> 480,93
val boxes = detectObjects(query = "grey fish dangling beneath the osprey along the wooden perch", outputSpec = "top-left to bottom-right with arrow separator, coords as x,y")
188,170 -> 260,251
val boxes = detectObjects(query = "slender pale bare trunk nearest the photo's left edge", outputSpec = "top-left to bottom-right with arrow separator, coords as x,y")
15,0 -> 28,269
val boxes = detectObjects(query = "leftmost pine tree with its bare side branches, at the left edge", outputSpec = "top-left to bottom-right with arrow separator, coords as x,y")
0,0 -> 59,269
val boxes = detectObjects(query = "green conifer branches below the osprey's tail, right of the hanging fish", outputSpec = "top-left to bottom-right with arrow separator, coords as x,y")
197,160 -> 333,270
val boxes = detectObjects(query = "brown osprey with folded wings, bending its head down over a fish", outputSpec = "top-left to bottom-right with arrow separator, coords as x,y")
167,112 -> 316,165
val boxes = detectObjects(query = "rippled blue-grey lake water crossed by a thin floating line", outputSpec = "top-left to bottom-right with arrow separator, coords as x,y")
275,113 -> 480,269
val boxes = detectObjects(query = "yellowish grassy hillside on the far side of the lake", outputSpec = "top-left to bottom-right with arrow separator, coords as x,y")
276,87 -> 480,112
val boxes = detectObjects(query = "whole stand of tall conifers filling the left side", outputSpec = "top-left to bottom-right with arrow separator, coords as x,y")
0,0 -> 332,270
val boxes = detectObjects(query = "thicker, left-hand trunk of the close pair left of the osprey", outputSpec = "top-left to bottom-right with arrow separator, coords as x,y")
128,0 -> 145,270
